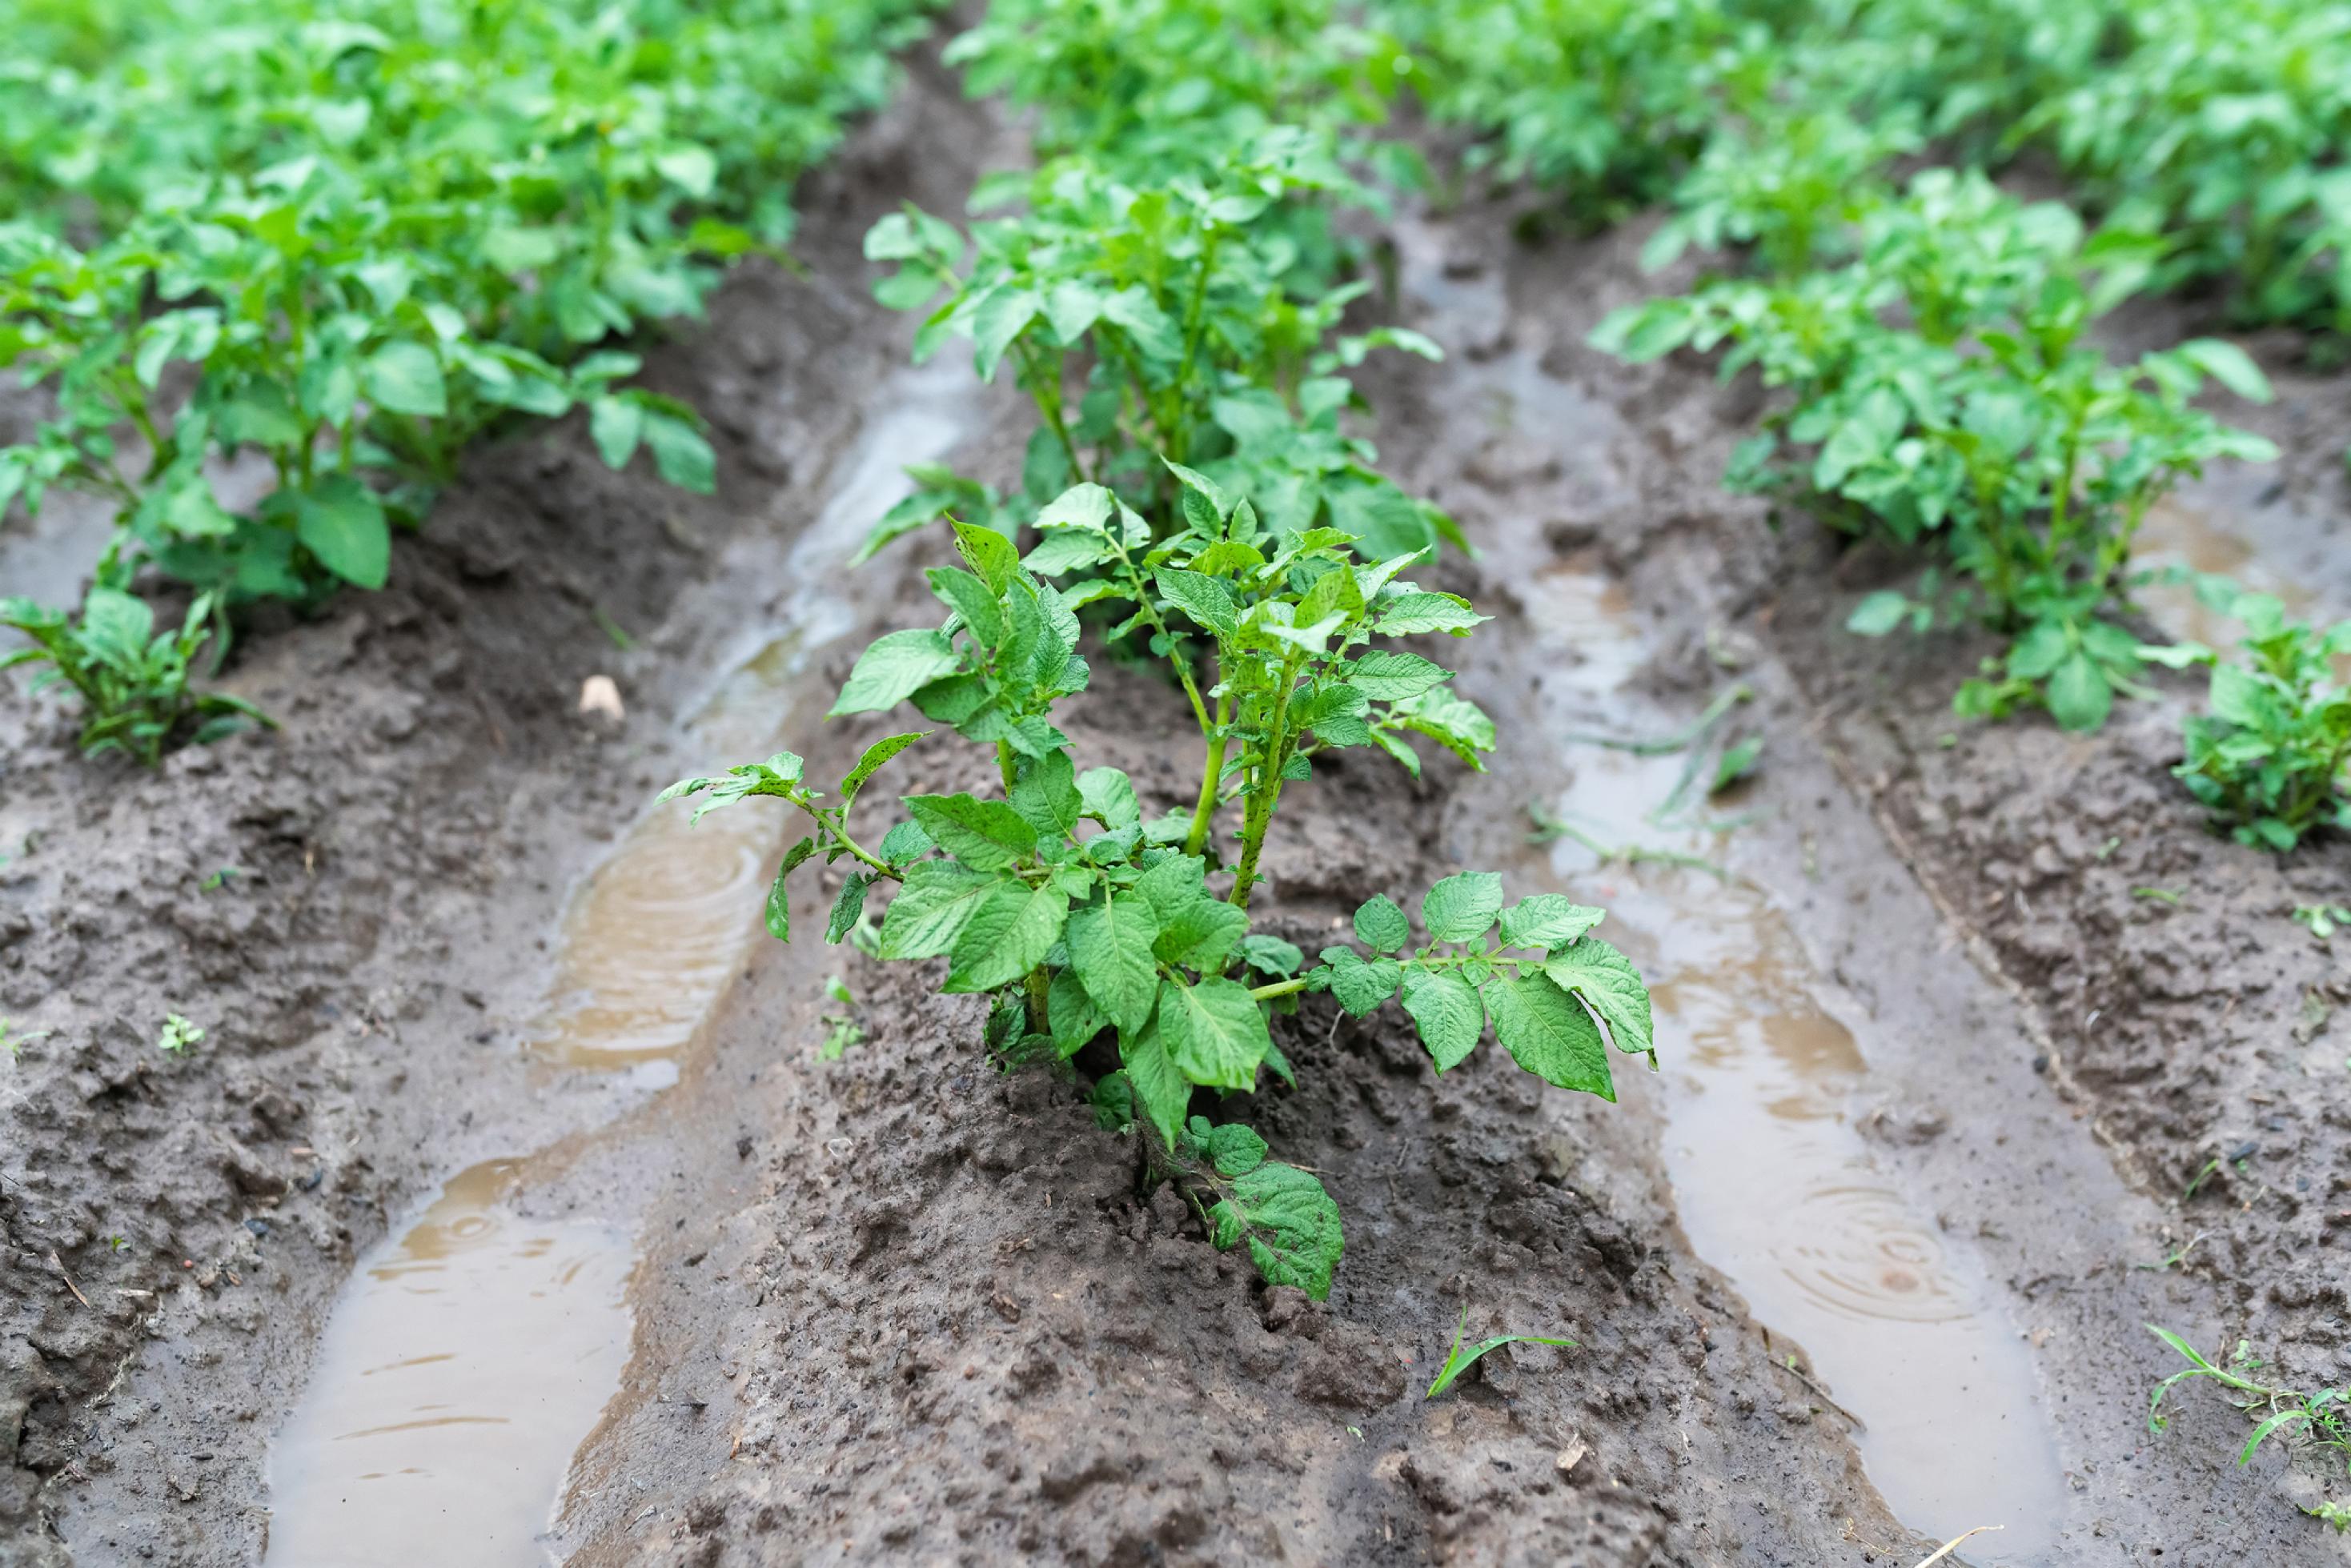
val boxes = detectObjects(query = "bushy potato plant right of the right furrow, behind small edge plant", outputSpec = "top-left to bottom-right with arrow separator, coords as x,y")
1594,169 -> 2276,731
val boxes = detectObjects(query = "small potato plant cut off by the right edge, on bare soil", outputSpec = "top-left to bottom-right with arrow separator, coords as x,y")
2172,592 -> 2351,853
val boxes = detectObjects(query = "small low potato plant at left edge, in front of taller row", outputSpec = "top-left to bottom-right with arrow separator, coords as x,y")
0,587 -> 278,766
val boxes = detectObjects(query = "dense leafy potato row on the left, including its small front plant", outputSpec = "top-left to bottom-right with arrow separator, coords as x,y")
0,0 -> 926,764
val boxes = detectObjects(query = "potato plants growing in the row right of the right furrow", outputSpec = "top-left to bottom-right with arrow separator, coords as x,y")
1382,0 -> 2351,851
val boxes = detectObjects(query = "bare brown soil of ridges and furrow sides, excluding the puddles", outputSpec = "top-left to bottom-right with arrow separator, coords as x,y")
0,51 -> 2351,1568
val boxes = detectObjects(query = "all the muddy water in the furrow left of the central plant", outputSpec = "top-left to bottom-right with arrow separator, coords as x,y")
268,376 -> 969,1568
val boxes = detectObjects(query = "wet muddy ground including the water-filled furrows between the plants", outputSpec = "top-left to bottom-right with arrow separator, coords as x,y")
0,58 -> 2351,1568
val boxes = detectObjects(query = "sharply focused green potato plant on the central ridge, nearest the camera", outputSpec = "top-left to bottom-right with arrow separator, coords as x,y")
663,479 -> 1653,1297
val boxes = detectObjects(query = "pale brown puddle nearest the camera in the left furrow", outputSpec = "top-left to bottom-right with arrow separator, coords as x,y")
263,1159 -> 632,1568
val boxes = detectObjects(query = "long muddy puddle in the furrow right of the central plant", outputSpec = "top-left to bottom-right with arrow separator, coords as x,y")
1528,569 -> 2067,1563
